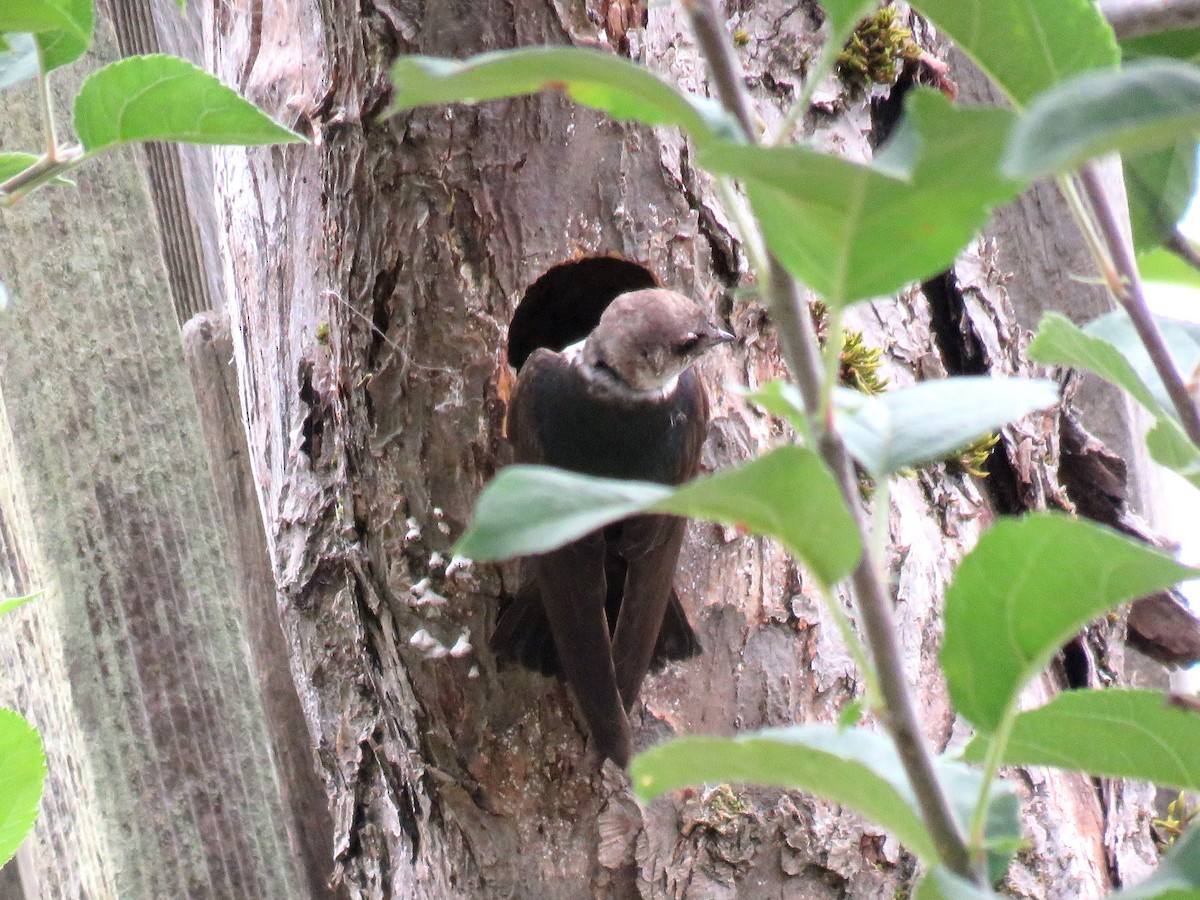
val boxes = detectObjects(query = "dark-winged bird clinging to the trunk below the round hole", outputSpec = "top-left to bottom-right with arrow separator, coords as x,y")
490,288 -> 734,768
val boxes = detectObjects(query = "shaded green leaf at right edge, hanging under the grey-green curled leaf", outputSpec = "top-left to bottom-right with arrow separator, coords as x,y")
1122,137 -> 1196,253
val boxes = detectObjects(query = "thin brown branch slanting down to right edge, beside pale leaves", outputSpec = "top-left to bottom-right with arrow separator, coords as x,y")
1080,163 -> 1200,446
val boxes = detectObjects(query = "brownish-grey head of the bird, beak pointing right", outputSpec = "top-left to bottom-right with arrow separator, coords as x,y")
583,288 -> 733,392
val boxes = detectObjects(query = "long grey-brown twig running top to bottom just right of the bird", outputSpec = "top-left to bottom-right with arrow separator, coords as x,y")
684,0 -> 977,881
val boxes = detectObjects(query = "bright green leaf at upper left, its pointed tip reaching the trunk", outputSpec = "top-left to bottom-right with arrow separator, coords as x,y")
74,54 -> 304,152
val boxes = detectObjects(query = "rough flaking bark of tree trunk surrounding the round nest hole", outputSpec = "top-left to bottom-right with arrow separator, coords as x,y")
211,0 -> 1148,898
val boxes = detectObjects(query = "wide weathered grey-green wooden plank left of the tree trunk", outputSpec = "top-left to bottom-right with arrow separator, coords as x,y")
0,24 -> 295,898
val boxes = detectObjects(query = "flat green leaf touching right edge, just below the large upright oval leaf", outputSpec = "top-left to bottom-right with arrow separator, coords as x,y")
964,688 -> 1200,791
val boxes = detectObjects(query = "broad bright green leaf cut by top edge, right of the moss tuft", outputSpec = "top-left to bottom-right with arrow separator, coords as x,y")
912,0 -> 1117,108
